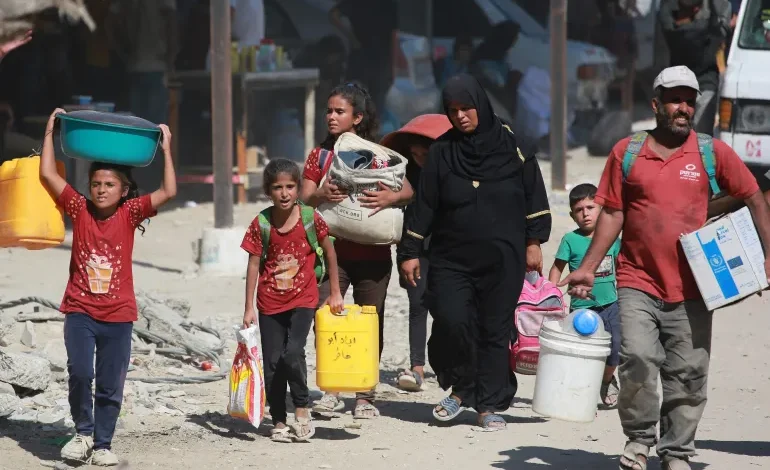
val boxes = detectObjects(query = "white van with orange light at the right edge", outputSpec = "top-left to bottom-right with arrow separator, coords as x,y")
719,0 -> 770,173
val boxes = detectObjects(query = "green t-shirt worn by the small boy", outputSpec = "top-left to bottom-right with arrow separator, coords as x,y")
556,230 -> 620,310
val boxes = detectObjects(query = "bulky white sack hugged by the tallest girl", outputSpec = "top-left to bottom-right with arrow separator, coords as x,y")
318,132 -> 407,245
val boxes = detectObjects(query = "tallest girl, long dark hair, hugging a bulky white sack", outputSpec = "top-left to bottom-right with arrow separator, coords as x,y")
300,82 -> 413,419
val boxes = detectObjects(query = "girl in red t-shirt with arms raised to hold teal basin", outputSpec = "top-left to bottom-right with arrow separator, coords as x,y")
40,109 -> 176,466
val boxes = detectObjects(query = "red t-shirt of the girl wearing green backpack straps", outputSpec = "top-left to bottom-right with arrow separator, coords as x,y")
241,212 -> 329,315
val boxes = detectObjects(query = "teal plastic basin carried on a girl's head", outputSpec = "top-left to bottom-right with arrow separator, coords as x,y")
57,113 -> 163,167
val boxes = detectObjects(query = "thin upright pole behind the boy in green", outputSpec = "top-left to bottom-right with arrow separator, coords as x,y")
550,0 -> 567,190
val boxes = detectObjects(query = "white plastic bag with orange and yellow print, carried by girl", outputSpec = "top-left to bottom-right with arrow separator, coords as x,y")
227,326 -> 266,428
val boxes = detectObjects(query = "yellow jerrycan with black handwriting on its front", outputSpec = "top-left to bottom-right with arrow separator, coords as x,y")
315,305 -> 380,392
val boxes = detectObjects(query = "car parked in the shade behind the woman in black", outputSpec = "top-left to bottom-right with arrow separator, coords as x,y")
388,0 -> 615,140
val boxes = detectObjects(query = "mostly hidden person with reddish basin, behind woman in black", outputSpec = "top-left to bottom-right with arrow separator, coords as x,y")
380,114 -> 452,392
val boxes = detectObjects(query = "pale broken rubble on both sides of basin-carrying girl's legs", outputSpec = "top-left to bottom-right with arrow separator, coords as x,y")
0,292 -> 231,430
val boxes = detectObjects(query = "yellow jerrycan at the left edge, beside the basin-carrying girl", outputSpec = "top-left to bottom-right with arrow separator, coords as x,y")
0,156 -> 65,250
